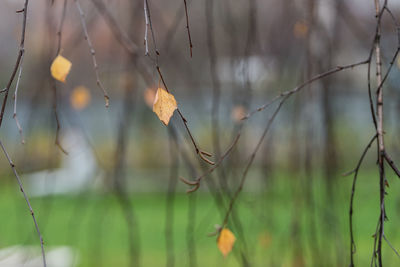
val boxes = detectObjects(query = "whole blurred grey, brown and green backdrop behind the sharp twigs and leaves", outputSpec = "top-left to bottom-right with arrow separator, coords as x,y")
0,0 -> 400,267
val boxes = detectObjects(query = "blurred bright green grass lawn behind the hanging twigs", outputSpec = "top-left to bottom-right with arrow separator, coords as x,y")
0,170 -> 400,266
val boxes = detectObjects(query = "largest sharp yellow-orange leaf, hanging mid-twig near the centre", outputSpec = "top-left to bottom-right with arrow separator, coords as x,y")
153,88 -> 178,125
